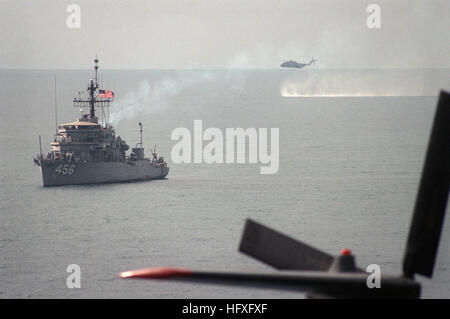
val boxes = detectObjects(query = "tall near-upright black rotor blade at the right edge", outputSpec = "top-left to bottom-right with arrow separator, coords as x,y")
403,91 -> 450,278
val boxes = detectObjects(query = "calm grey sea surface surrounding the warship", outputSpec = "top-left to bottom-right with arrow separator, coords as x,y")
0,69 -> 450,298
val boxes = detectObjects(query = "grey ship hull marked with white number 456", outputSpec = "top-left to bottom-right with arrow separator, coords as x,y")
40,160 -> 169,187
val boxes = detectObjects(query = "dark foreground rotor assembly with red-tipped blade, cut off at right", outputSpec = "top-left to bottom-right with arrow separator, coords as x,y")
118,91 -> 450,298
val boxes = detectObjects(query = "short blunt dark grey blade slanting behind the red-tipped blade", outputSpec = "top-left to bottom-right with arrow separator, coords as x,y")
239,219 -> 333,271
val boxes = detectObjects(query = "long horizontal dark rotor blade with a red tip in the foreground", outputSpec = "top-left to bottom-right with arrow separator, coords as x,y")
119,267 -> 420,298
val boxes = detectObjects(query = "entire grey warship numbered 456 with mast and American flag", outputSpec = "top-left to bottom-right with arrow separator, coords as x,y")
34,58 -> 169,187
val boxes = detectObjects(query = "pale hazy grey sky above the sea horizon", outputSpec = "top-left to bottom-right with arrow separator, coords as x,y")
0,0 -> 450,69
